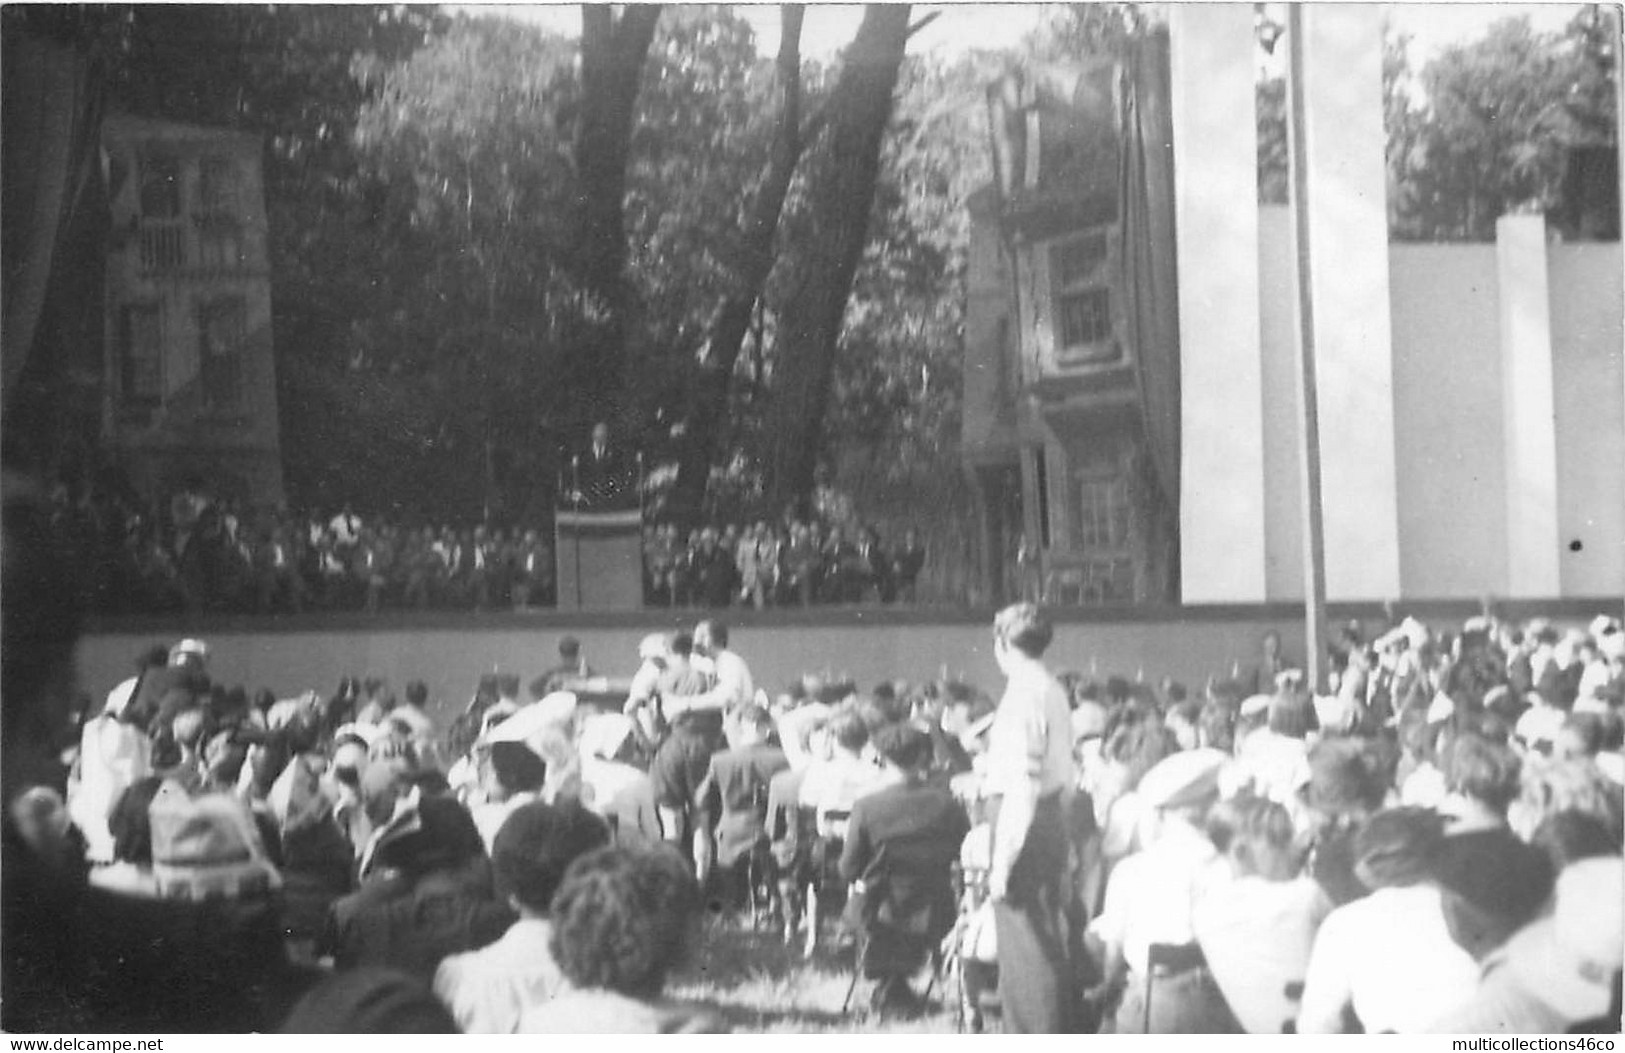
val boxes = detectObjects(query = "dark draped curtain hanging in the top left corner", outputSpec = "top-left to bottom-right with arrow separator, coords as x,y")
0,12 -> 107,429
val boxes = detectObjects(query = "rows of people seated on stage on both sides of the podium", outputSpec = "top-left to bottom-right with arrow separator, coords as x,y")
52,484 -> 925,614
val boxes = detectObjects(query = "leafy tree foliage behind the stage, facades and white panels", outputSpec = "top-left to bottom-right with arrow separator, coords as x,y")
98,3 -> 1615,542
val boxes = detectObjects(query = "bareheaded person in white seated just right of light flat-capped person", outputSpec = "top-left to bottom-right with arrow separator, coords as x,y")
1191,796 -> 1331,1035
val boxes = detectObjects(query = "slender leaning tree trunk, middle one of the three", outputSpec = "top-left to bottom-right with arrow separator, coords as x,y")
671,3 -> 806,523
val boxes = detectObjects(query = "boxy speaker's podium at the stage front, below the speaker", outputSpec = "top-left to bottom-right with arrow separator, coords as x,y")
553,509 -> 644,611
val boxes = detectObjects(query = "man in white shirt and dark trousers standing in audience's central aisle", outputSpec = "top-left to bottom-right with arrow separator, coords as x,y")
985,603 -> 1077,1035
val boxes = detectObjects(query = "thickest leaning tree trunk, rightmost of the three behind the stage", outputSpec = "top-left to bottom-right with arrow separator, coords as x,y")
769,3 -> 910,509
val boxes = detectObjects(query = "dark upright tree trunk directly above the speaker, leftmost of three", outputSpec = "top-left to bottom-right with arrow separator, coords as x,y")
567,3 -> 660,418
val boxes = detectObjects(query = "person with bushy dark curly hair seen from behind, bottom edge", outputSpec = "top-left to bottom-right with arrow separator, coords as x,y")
518,845 -> 722,1035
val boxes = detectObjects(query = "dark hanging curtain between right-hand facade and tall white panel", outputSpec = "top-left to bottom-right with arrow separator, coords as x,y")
1118,29 -> 1180,600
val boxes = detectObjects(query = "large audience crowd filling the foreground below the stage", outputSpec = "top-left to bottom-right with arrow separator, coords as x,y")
0,477 -> 1625,1034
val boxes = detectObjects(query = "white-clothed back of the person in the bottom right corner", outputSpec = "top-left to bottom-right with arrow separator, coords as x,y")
1432,855 -> 1625,1034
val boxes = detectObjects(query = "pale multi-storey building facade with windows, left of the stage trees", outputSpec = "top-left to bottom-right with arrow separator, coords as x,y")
102,115 -> 283,504
